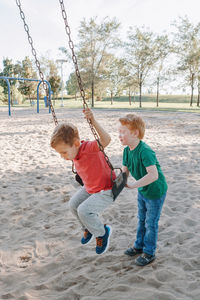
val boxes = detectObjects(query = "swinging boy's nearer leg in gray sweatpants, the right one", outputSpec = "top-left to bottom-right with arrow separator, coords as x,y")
78,190 -> 113,237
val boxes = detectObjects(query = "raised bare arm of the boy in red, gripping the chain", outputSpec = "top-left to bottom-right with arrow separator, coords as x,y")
83,108 -> 111,148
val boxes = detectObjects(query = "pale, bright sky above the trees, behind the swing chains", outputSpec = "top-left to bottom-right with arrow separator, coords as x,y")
0,0 -> 200,79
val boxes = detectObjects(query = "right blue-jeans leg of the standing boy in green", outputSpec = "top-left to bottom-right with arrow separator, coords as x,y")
143,194 -> 166,255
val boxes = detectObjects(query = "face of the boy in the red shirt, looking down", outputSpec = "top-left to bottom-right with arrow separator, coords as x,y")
55,140 -> 80,160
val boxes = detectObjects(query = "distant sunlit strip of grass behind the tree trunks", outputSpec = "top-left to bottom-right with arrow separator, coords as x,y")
1,95 -> 200,112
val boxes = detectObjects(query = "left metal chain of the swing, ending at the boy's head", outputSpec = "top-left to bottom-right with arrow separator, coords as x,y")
16,0 -> 58,125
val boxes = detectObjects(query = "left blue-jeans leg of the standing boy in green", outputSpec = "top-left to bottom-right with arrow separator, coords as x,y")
134,192 -> 146,249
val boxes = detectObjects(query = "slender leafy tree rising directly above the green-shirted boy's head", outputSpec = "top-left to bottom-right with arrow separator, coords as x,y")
125,27 -> 162,107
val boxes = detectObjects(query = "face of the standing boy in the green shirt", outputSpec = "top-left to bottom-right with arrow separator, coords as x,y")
118,123 -> 138,146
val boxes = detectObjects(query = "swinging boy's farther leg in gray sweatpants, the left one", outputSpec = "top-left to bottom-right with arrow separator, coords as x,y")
69,187 -> 90,230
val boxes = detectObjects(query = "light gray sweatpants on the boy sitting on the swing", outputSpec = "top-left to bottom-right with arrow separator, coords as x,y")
69,186 -> 113,237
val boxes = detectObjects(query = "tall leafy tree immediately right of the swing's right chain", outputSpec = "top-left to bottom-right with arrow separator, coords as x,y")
78,18 -> 120,107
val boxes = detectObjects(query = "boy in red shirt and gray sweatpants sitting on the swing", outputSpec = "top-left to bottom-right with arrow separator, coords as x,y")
50,108 -> 115,254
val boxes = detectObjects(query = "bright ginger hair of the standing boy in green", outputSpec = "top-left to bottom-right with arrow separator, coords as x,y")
119,114 -> 145,140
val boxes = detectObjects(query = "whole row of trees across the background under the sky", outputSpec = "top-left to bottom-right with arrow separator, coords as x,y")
0,16 -> 200,107
